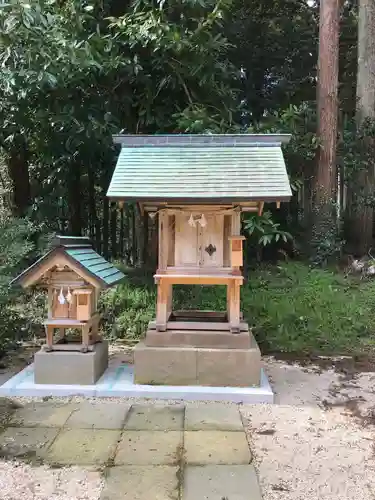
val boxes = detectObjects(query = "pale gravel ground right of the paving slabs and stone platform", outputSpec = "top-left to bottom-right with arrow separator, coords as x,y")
241,359 -> 375,500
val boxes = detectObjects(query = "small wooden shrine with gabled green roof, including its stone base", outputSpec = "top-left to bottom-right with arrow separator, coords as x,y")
11,236 -> 124,383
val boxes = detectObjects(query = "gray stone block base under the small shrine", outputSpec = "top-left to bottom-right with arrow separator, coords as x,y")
34,341 -> 108,385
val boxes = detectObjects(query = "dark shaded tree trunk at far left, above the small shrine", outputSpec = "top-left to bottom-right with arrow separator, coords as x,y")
8,144 -> 31,217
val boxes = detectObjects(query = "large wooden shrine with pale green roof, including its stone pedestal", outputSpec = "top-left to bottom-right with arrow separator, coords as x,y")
108,134 -> 291,386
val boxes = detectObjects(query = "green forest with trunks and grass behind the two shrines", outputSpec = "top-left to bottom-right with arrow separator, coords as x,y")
0,0 -> 375,355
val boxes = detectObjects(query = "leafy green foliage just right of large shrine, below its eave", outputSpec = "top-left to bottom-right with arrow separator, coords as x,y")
244,211 -> 293,246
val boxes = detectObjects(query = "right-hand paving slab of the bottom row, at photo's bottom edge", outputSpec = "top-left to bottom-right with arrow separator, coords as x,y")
182,465 -> 262,500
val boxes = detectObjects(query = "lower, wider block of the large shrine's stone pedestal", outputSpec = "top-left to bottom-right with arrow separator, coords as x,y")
134,332 -> 261,387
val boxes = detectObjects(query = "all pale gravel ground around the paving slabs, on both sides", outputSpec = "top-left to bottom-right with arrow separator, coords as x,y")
0,352 -> 375,500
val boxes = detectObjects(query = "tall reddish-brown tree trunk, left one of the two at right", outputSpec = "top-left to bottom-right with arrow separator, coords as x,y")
312,0 -> 340,258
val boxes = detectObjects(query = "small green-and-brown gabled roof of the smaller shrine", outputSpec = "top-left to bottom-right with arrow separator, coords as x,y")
10,236 -> 125,287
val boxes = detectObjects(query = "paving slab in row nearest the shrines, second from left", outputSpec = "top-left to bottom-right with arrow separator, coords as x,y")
65,401 -> 131,429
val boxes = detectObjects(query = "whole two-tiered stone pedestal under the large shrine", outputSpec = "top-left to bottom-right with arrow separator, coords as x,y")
134,326 -> 261,387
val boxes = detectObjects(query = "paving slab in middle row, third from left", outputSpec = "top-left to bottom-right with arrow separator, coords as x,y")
115,431 -> 182,465
